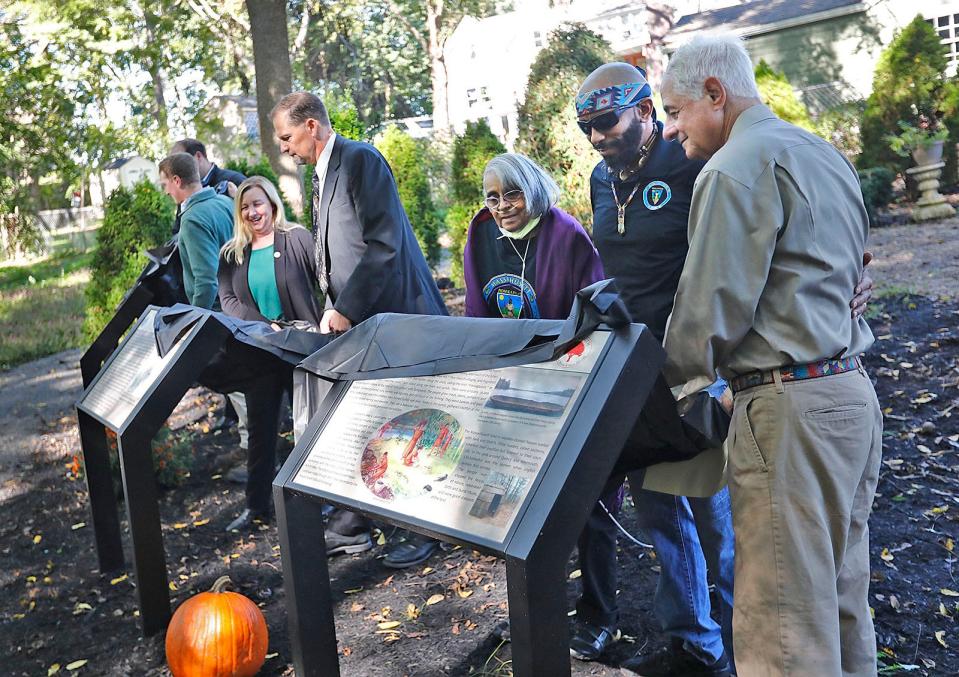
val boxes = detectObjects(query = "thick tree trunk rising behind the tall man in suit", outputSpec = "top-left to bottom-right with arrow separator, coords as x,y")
246,0 -> 303,214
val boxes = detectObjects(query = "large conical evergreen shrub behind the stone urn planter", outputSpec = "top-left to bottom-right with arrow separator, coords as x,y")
857,16 -> 959,181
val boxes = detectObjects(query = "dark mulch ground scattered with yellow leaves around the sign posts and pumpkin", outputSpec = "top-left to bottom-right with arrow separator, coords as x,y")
0,296 -> 959,677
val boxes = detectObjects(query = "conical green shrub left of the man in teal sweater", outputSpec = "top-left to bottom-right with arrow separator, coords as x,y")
83,181 -> 175,341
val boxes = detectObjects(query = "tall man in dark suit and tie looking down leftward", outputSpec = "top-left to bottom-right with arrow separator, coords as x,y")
271,92 -> 447,567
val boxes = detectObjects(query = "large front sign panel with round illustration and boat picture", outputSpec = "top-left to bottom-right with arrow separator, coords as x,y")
293,332 -> 609,544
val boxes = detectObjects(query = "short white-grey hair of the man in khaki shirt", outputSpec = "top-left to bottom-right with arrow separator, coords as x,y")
661,34 -> 759,99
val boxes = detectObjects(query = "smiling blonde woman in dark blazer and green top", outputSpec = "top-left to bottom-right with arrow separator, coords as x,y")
217,176 -> 323,327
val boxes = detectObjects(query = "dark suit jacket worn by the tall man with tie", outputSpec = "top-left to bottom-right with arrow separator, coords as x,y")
314,136 -> 447,325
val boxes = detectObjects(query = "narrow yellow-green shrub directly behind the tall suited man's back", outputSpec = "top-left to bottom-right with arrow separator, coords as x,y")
377,126 -> 440,266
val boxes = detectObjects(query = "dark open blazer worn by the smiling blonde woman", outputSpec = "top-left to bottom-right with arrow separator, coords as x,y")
218,226 -> 323,327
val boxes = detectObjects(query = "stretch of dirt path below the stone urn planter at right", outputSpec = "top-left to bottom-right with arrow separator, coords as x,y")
869,218 -> 959,298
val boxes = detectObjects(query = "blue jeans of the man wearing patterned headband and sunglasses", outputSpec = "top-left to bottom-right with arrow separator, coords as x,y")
633,488 -> 734,663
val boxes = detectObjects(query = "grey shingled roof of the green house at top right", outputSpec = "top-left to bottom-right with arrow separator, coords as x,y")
672,0 -> 865,35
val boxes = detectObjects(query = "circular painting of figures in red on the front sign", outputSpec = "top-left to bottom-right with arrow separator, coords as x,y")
360,409 -> 463,501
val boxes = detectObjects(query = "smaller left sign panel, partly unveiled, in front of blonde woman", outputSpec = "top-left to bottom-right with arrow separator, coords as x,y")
80,310 -> 197,430
